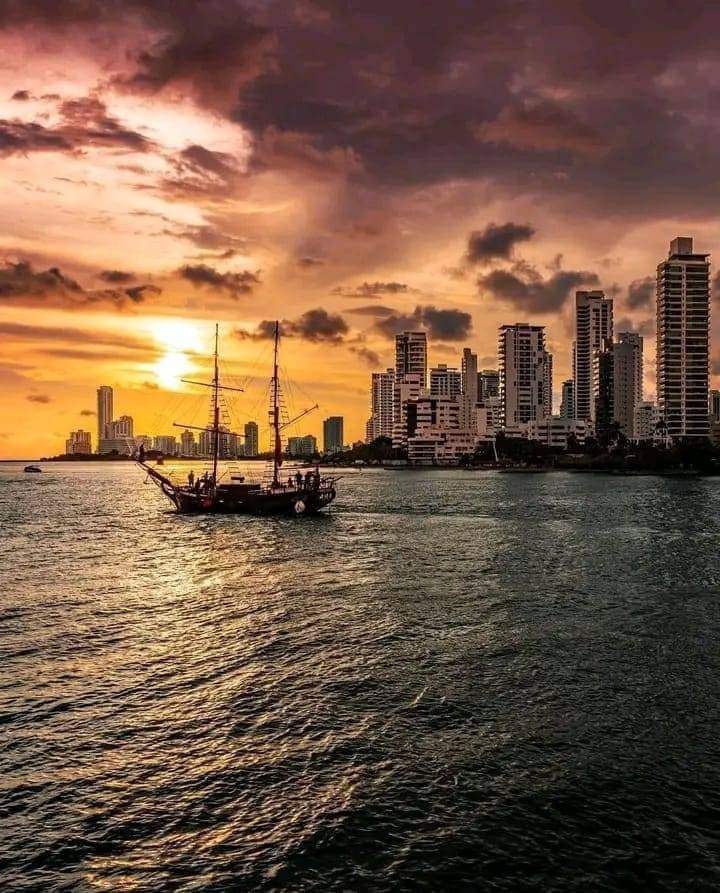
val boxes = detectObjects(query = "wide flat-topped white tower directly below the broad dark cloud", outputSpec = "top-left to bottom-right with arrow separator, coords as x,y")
498,323 -> 552,428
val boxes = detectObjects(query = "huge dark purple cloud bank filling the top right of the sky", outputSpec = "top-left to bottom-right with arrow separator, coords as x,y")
9,0 -> 720,223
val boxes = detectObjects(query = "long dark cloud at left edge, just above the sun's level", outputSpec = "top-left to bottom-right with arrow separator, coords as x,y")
0,261 -> 160,309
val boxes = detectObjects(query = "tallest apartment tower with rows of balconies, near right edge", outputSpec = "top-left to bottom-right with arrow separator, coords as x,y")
657,236 -> 710,438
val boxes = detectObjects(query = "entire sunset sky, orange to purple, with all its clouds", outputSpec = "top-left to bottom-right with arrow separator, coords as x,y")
0,0 -> 720,457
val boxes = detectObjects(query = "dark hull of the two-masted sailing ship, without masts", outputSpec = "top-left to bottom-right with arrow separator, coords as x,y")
146,462 -> 336,515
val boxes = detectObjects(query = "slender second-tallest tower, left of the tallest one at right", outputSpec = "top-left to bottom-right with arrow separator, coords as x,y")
573,291 -> 613,421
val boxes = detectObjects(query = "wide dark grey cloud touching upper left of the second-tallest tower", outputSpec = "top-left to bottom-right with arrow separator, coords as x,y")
477,270 -> 599,313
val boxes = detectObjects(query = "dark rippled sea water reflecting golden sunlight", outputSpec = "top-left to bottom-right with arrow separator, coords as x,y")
0,463 -> 720,893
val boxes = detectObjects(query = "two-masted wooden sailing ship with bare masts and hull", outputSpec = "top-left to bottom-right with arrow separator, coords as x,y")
133,321 -> 337,515
